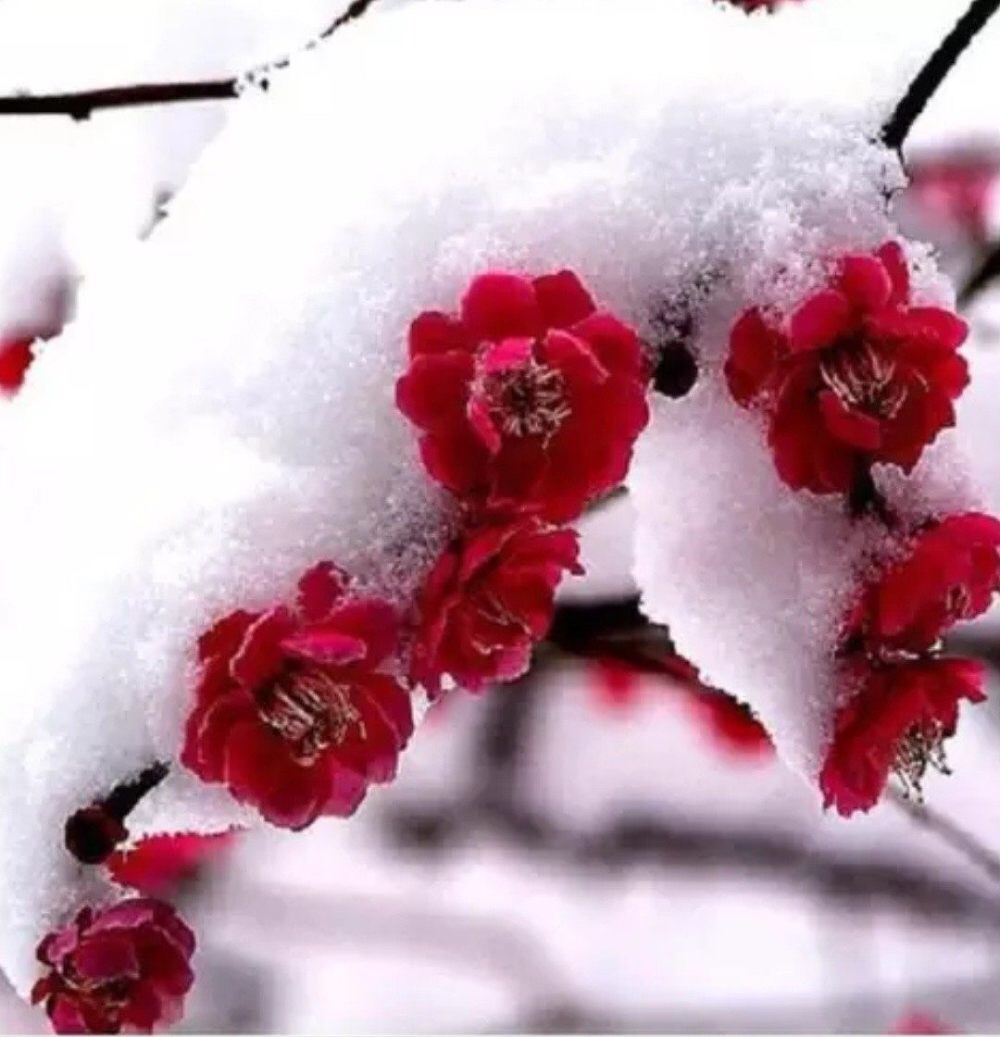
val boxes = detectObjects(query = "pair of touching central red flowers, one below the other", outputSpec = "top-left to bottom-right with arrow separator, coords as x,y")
396,271 -> 649,696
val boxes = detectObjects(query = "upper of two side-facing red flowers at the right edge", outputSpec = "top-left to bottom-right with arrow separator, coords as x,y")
857,512 -> 1000,652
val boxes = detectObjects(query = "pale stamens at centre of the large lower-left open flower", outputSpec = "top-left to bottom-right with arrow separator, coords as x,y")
257,667 -> 364,765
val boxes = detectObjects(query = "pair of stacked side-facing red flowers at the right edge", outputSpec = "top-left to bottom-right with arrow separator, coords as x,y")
820,513 -> 1000,816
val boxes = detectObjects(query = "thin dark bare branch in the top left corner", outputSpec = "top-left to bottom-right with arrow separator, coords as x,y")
0,0 -> 377,121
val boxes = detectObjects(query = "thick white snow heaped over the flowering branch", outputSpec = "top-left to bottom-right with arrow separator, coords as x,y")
0,0 -> 987,989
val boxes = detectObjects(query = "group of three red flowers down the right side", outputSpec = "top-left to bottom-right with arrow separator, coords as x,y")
725,242 -> 1000,816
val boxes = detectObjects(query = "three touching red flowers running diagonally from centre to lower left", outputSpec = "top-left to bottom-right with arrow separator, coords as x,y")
173,272 -> 646,858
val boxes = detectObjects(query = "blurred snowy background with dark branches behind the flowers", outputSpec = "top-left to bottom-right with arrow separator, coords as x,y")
0,0 -> 1000,1034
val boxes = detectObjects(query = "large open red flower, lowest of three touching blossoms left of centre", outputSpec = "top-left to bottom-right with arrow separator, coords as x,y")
182,564 -> 413,829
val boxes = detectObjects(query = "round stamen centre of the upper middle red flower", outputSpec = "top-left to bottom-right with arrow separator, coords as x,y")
481,358 -> 571,439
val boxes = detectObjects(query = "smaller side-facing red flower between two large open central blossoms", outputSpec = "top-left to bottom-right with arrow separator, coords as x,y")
411,516 -> 583,695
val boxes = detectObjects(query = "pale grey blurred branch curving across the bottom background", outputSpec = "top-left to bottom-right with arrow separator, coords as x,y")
208,881 -> 997,1034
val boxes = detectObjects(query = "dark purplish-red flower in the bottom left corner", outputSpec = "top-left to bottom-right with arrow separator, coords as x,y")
31,898 -> 195,1034
